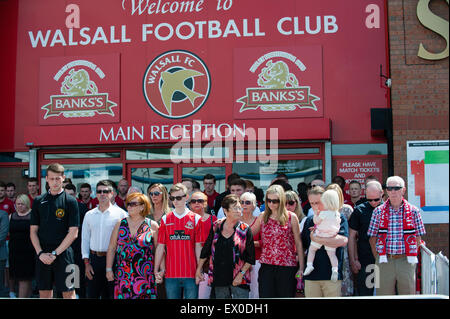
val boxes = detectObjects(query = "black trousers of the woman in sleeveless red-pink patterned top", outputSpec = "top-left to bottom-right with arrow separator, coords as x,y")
258,264 -> 298,298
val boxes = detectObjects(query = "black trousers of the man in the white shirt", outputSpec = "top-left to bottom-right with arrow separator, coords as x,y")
86,254 -> 114,299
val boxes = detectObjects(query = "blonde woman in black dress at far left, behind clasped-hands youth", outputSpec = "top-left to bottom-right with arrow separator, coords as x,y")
9,194 -> 36,298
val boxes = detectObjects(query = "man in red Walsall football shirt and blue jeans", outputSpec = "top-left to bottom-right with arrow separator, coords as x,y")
155,183 -> 202,299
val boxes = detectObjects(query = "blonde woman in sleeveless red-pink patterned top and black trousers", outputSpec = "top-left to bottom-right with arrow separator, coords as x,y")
254,185 -> 305,298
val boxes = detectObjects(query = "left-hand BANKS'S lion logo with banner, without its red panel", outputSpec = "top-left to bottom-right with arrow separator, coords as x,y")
42,60 -> 117,119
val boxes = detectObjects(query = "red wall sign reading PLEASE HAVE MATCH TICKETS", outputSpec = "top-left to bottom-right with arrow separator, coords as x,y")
336,158 -> 383,193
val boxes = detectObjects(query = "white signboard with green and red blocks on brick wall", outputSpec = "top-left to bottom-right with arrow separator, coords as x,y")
406,140 -> 449,224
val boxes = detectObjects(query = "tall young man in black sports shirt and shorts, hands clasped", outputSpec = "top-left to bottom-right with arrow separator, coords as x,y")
30,163 -> 80,299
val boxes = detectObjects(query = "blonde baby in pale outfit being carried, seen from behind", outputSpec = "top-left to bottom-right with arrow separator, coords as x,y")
303,189 -> 341,281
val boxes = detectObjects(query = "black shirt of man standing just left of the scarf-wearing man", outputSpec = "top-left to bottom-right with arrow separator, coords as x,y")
348,202 -> 375,265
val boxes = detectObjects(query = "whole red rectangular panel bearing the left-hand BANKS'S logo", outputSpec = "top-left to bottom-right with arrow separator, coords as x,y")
39,54 -> 120,125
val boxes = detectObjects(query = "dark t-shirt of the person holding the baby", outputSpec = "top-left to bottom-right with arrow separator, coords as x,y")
301,214 -> 348,280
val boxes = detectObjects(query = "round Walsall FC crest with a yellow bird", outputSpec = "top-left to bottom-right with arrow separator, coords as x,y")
143,50 -> 211,119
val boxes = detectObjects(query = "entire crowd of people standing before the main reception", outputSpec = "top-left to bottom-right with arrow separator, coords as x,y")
0,163 -> 425,299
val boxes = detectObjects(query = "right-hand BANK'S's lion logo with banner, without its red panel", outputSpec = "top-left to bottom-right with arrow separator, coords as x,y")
237,51 -> 320,113
